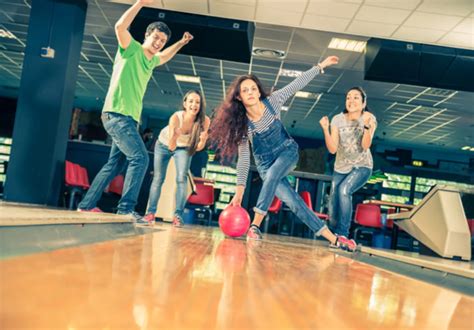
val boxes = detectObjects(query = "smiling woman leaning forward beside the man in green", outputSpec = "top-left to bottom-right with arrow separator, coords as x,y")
145,90 -> 210,226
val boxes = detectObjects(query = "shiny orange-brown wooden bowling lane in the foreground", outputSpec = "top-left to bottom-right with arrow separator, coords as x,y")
0,224 -> 474,329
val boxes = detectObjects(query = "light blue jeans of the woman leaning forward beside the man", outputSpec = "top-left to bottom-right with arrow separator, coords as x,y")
147,141 -> 192,219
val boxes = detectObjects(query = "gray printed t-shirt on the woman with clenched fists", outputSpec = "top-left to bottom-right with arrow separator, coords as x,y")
331,113 -> 377,174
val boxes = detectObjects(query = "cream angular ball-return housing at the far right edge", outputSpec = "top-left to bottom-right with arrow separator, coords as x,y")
388,185 -> 471,260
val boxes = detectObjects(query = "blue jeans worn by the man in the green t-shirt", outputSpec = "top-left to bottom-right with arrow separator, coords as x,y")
79,112 -> 149,213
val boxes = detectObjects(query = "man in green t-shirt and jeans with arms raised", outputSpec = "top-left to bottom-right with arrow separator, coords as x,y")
78,0 -> 193,224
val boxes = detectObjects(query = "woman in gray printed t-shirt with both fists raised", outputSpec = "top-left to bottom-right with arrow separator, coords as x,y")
319,87 -> 377,236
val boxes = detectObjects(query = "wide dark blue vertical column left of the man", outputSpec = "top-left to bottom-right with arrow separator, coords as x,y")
4,0 -> 87,205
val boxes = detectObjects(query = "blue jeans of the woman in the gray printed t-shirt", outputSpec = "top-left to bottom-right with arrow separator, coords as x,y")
329,167 -> 372,237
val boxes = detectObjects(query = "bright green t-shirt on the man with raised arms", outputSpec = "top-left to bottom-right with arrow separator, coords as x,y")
102,39 -> 160,122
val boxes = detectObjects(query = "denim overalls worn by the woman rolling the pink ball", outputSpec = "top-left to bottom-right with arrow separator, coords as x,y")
248,99 -> 327,236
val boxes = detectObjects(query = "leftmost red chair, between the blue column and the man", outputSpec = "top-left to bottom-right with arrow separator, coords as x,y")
64,160 -> 90,210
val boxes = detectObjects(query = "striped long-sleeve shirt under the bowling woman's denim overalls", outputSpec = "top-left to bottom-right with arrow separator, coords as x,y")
237,66 -> 321,186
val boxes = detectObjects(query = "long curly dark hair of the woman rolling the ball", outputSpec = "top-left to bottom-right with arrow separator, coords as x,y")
209,74 -> 268,161
